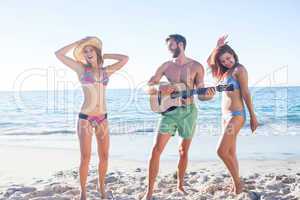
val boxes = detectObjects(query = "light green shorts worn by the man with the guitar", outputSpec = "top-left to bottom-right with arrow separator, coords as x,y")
158,104 -> 198,139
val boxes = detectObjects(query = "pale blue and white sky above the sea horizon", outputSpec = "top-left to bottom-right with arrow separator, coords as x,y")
0,0 -> 300,90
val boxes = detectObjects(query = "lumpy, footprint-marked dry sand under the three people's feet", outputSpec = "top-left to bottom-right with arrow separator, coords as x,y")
0,159 -> 300,200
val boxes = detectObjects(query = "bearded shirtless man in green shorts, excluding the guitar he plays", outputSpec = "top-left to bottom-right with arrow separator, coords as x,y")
144,34 -> 215,200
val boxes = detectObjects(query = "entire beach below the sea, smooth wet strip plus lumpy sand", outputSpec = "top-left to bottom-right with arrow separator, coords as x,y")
0,135 -> 300,200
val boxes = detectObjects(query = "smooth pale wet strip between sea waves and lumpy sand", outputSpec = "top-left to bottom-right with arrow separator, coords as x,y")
0,135 -> 300,184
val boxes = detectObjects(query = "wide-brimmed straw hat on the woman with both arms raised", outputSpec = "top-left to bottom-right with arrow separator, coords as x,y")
73,37 -> 102,62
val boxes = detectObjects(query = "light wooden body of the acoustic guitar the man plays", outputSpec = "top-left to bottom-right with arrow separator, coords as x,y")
150,83 -> 187,113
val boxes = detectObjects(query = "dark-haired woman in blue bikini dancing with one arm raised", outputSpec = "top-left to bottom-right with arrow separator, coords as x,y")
207,36 -> 258,194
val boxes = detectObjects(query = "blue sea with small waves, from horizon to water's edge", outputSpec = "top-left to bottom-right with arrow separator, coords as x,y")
0,87 -> 300,137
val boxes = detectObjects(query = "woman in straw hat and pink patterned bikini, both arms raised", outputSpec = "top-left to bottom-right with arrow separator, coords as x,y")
55,37 -> 128,199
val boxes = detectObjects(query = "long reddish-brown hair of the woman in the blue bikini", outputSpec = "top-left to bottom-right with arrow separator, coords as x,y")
208,44 -> 239,80
